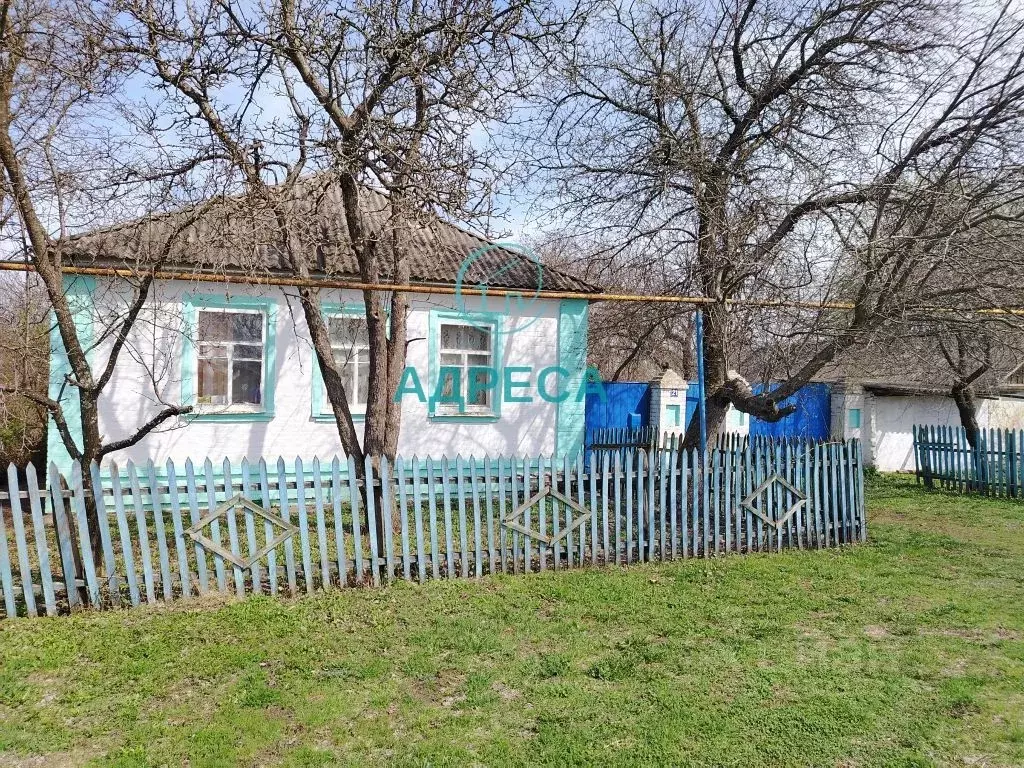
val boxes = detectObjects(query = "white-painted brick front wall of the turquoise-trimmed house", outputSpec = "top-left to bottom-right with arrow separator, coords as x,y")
49,279 -> 586,464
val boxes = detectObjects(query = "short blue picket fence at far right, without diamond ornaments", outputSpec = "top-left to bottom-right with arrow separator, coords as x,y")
913,425 -> 1024,499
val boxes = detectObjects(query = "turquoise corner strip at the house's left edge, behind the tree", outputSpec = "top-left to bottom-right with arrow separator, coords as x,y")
46,274 -> 96,477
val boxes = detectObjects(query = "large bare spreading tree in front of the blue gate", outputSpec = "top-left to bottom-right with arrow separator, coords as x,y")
535,0 -> 1024,443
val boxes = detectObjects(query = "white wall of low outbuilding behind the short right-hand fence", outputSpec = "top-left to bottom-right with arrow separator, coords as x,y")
833,385 -> 1024,472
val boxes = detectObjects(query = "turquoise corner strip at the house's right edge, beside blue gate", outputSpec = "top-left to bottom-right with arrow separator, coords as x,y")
555,299 -> 590,459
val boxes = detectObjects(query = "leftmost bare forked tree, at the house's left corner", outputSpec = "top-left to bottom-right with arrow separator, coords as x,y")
0,0 -> 230,557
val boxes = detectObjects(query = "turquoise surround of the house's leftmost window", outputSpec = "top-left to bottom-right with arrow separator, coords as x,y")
181,294 -> 278,422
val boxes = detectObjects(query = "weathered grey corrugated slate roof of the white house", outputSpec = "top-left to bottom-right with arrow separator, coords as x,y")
66,176 -> 600,294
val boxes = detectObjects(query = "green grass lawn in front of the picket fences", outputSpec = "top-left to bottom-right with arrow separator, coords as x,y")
0,479 -> 1024,766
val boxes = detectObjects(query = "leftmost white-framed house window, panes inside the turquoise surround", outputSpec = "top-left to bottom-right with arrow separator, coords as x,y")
196,308 -> 266,413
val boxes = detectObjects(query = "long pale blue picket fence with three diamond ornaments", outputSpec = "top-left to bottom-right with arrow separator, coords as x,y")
0,441 -> 866,616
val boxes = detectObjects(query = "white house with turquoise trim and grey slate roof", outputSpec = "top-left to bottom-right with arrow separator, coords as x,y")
48,186 -> 598,479
